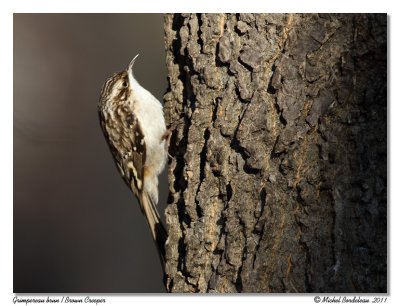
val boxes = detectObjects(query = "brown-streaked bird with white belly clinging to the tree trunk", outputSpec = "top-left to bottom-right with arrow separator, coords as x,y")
98,55 -> 167,260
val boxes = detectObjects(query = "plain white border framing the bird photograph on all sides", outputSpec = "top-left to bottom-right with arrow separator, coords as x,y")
0,0 -> 400,306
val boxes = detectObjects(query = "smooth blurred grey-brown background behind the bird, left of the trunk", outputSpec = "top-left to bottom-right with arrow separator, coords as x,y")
13,14 -> 168,293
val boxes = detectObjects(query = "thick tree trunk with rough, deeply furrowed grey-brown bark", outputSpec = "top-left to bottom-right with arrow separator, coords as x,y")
165,14 -> 387,292
